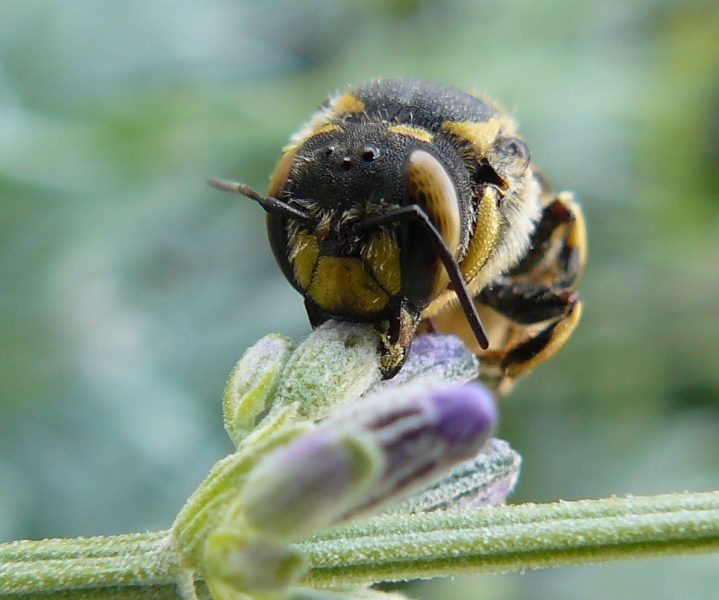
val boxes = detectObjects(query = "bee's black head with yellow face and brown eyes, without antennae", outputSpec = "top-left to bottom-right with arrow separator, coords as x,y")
268,122 -> 471,321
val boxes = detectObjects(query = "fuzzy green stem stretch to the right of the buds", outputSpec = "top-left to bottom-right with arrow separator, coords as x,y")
298,492 -> 719,586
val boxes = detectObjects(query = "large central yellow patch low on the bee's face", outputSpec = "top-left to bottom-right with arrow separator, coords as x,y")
307,256 -> 389,315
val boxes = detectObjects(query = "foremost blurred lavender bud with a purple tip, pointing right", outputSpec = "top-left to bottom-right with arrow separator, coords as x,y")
243,380 -> 496,536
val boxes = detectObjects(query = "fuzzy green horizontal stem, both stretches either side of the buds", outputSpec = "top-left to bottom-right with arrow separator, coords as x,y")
0,492 -> 719,600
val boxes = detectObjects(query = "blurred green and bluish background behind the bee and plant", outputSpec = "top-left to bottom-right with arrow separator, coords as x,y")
0,0 -> 719,600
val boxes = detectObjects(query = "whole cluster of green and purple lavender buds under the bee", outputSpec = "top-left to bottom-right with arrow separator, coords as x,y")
172,322 -> 520,600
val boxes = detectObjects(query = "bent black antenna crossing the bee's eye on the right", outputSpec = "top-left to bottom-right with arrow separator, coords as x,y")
357,204 -> 489,350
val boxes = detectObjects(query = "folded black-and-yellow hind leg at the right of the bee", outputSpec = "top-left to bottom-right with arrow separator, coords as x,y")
476,192 -> 586,393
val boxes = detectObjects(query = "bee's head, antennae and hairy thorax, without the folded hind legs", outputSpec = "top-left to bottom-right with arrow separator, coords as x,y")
211,79 -> 583,384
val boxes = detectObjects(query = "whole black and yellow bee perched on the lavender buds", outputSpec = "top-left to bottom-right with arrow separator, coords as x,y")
209,79 -> 586,393
